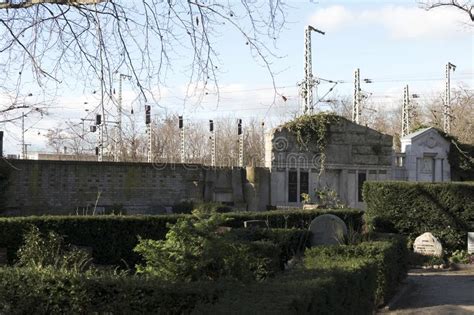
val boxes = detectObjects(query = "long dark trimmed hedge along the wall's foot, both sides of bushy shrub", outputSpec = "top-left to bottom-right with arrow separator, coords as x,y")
0,209 -> 362,267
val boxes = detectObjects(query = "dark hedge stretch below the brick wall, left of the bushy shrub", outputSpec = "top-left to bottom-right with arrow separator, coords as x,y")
0,215 -> 182,266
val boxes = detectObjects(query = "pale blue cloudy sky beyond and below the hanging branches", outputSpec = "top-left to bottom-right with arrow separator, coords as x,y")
0,0 -> 474,154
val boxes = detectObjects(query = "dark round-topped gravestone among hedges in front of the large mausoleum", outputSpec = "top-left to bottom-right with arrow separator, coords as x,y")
309,214 -> 347,246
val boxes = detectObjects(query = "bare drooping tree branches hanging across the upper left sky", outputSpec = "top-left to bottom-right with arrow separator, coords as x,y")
0,0 -> 285,100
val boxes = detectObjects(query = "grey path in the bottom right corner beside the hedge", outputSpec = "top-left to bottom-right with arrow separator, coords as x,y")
378,270 -> 474,315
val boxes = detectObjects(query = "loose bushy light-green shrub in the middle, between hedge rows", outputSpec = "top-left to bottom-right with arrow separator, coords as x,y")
135,214 -> 279,282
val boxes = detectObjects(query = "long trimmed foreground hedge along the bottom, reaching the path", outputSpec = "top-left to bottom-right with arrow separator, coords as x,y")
0,241 -> 403,314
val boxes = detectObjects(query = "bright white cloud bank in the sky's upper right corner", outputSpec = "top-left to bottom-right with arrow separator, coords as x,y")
309,5 -> 474,39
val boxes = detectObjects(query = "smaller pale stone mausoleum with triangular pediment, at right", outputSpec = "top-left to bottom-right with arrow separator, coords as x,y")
393,127 -> 451,182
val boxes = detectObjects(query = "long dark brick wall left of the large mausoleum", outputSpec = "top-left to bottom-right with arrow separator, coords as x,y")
0,160 -> 268,215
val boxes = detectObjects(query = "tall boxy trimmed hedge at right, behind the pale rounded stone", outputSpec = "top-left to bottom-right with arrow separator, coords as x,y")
364,182 -> 474,252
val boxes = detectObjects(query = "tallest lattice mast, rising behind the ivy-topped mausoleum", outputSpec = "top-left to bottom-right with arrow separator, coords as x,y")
301,25 -> 325,115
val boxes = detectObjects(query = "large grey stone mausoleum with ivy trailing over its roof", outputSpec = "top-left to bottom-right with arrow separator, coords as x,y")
265,114 -> 393,208
